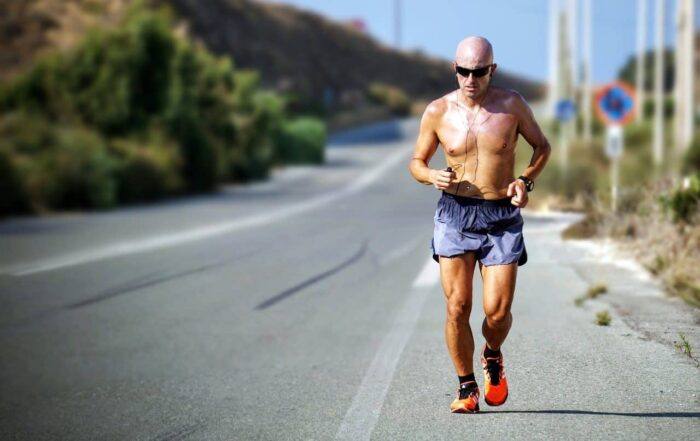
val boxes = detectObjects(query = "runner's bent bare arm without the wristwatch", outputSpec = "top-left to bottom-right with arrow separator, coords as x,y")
408,100 -> 456,190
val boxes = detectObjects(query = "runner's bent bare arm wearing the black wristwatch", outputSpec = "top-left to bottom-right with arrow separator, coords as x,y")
508,93 -> 552,207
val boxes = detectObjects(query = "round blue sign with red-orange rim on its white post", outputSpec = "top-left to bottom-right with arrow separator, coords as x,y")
596,81 -> 636,212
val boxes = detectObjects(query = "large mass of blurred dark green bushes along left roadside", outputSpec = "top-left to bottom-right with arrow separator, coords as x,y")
0,2 -> 298,210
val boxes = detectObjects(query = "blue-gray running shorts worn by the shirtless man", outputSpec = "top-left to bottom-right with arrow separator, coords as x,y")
430,191 -> 527,266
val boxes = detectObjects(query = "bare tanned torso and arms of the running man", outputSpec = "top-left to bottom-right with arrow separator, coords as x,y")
413,86 -> 548,206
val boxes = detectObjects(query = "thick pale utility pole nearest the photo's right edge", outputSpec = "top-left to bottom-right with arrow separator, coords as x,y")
674,0 -> 695,156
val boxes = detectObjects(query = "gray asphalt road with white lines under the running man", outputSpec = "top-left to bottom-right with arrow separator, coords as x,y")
0,121 -> 700,440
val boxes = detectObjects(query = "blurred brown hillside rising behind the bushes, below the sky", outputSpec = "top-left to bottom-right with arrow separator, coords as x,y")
0,0 -> 543,105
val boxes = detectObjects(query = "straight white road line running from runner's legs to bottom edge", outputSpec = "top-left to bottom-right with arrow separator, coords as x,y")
335,257 -> 440,441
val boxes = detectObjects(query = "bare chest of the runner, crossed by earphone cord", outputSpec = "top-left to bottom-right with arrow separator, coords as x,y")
437,109 -> 518,156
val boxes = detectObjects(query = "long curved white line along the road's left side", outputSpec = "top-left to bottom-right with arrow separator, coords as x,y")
0,146 -> 407,276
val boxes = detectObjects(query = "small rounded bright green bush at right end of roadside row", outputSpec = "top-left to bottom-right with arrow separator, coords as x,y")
277,117 -> 326,164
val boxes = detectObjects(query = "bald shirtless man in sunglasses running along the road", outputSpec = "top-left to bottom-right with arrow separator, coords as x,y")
409,37 -> 551,413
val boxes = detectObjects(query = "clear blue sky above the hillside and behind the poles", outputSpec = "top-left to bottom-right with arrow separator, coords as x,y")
266,0 -> 700,84
